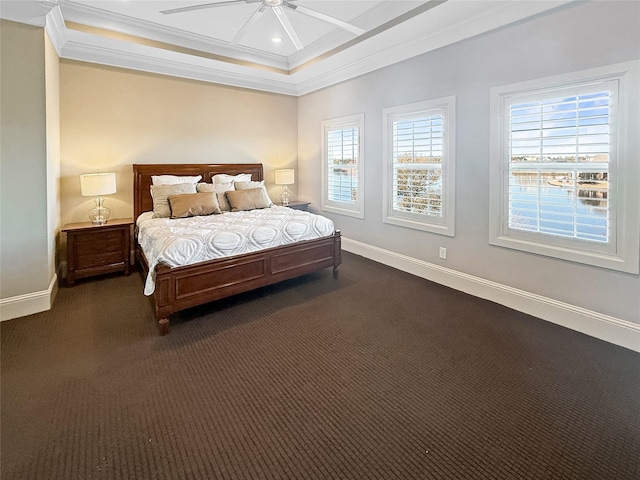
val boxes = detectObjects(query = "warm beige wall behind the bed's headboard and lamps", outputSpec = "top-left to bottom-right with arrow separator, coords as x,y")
60,60 -> 298,224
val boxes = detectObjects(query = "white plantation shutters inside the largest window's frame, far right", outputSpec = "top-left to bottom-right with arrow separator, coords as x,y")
507,81 -> 617,243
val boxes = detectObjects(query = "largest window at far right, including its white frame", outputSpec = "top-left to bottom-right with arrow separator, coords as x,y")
491,62 -> 638,273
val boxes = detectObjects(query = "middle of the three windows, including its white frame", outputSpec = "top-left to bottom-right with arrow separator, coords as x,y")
383,97 -> 455,236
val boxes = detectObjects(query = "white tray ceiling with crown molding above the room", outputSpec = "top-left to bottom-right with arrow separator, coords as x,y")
0,0 -> 571,95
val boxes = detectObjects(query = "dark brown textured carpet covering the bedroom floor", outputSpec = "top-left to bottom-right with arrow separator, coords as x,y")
1,253 -> 640,480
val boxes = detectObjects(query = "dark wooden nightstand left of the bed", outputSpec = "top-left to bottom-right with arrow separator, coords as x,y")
62,218 -> 133,285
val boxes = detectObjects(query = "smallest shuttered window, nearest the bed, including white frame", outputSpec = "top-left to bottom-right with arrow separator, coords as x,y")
322,114 -> 364,218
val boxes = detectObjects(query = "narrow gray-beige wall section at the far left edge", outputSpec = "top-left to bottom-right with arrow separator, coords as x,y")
0,20 -> 53,299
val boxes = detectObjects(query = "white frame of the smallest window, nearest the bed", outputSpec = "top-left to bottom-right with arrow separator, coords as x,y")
321,113 -> 365,219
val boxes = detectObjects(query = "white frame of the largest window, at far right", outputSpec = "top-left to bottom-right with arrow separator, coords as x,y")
489,61 -> 640,274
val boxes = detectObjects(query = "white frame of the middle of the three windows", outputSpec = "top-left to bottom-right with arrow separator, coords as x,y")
382,96 -> 456,237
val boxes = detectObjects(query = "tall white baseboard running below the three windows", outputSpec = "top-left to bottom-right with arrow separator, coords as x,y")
342,237 -> 640,352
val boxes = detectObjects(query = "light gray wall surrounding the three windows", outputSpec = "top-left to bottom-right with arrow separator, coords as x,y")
298,2 -> 640,323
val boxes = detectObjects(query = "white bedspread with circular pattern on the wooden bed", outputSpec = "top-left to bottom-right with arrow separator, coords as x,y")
136,205 -> 334,295
